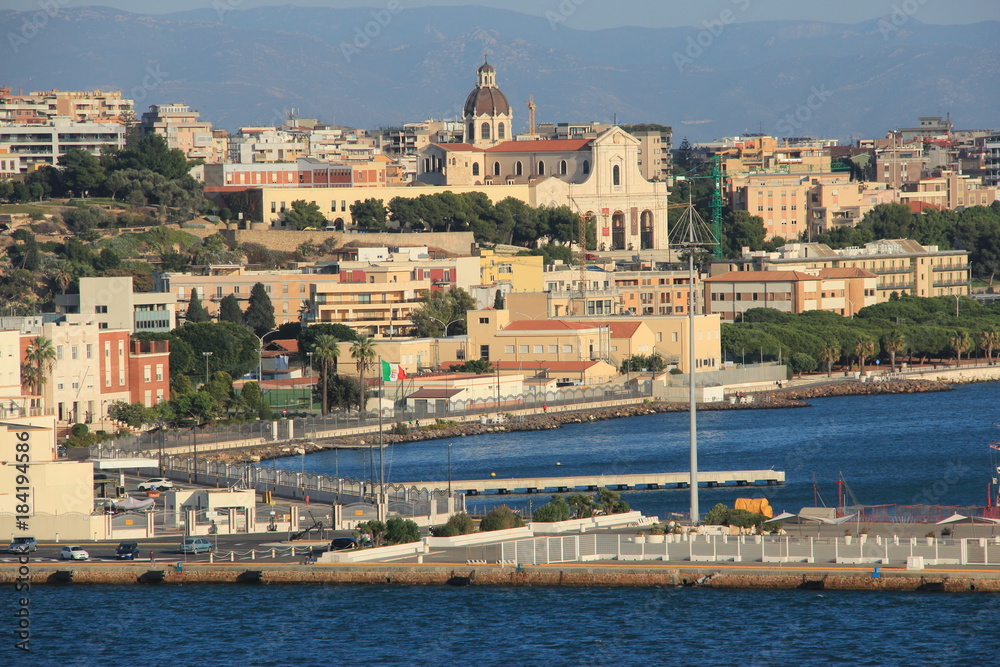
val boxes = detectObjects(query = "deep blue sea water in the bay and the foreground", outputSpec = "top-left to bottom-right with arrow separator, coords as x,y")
13,384 -> 1000,666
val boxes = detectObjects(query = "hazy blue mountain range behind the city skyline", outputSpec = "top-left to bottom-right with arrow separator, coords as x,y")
0,2 -> 1000,142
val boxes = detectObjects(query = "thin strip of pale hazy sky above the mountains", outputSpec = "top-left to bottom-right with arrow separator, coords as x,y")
0,0 -> 1000,30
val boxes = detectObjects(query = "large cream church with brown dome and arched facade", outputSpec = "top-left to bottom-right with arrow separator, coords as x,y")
417,62 -> 668,251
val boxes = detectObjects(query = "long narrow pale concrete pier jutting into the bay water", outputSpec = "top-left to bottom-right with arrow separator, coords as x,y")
410,470 -> 785,496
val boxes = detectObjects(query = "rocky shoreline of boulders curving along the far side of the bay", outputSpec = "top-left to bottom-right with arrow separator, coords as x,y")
218,380 -> 952,461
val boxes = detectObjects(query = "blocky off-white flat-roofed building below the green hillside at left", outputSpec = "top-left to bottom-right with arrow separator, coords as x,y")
56,276 -> 177,333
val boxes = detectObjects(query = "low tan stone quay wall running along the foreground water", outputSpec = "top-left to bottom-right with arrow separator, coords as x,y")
0,563 -> 1000,593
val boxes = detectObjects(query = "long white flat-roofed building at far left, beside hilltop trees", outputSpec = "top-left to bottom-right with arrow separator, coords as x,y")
0,116 -> 125,174
